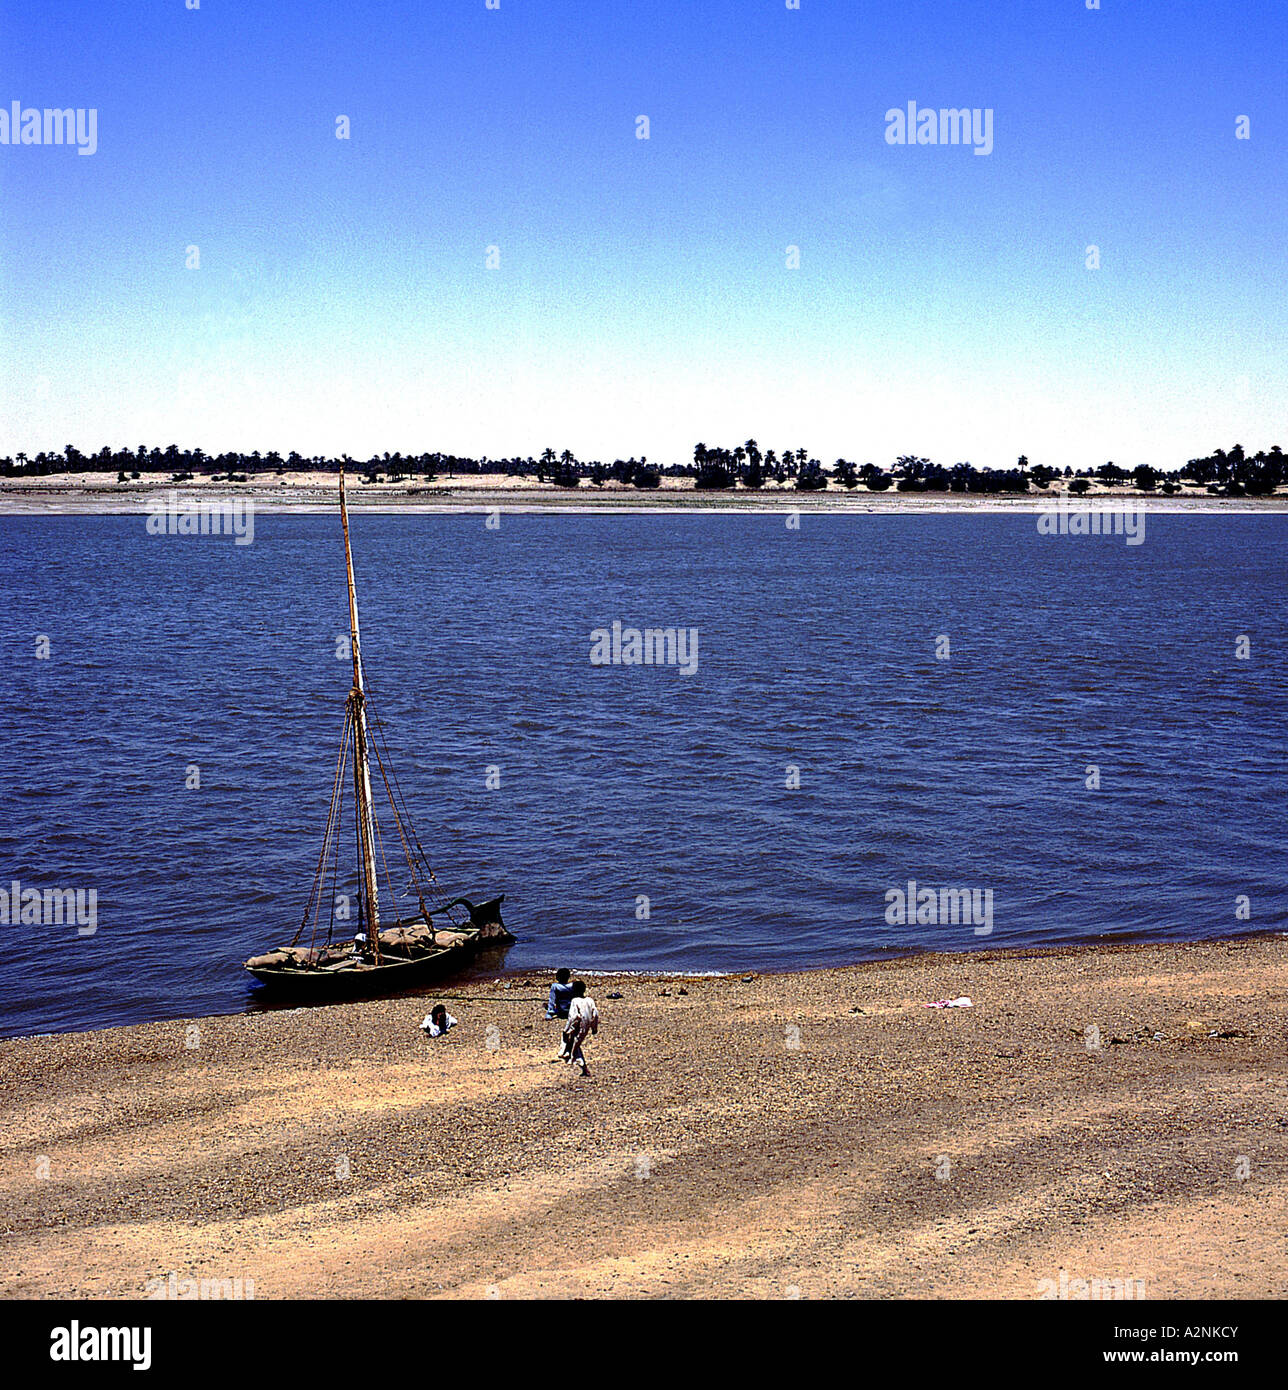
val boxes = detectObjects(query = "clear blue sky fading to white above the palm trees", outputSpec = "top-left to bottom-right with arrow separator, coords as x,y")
0,0 -> 1288,466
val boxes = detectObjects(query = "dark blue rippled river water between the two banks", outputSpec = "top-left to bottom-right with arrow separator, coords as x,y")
0,514 -> 1288,1034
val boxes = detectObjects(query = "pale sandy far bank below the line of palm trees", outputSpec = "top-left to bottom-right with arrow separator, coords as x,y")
0,473 -> 1288,516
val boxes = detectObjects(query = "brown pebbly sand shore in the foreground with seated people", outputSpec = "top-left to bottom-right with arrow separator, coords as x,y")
0,937 -> 1288,1300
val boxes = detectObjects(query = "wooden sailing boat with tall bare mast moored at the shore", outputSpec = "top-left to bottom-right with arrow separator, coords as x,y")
246,468 -> 514,998
